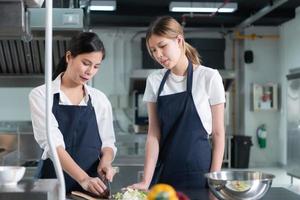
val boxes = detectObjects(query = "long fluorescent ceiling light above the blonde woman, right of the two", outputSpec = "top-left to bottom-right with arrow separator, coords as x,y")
169,2 -> 237,13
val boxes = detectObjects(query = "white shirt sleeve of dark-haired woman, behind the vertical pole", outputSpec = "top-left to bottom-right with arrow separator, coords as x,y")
29,86 -> 65,160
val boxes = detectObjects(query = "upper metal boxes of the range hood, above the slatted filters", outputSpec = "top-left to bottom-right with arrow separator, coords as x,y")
0,0 -> 83,39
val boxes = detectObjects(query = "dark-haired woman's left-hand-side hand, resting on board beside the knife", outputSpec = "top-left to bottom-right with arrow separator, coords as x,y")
79,176 -> 106,195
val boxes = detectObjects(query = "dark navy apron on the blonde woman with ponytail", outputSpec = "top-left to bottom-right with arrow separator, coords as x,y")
151,62 -> 211,190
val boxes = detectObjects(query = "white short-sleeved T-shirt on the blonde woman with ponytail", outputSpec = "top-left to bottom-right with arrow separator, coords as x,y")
143,65 -> 225,134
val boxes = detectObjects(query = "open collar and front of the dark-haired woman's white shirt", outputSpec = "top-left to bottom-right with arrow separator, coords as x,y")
52,72 -> 90,105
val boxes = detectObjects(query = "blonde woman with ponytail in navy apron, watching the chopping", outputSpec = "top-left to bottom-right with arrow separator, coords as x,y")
131,16 -> 225,190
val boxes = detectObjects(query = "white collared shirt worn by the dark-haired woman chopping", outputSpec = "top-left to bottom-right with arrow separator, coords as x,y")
29,74 -> 117,159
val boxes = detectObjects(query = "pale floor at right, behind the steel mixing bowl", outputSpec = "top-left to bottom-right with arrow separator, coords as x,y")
250,167 -> 300,194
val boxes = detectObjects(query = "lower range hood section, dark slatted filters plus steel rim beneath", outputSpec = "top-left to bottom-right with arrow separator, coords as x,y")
0,37 -> 69,87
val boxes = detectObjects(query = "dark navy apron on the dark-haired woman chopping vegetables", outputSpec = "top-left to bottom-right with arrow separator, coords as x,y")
38,93 -> 102,193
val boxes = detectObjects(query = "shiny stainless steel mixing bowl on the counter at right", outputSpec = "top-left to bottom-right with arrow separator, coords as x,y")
205,170 -> 275,200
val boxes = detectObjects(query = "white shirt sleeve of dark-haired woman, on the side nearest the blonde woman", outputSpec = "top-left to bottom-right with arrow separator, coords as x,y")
92,93 -> 117,157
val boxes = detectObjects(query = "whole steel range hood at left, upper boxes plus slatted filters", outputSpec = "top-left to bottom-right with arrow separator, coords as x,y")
0,0 -> 84,87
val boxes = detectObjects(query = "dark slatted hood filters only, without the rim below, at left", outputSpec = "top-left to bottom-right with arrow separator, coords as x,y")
0,38 -> 70,75
